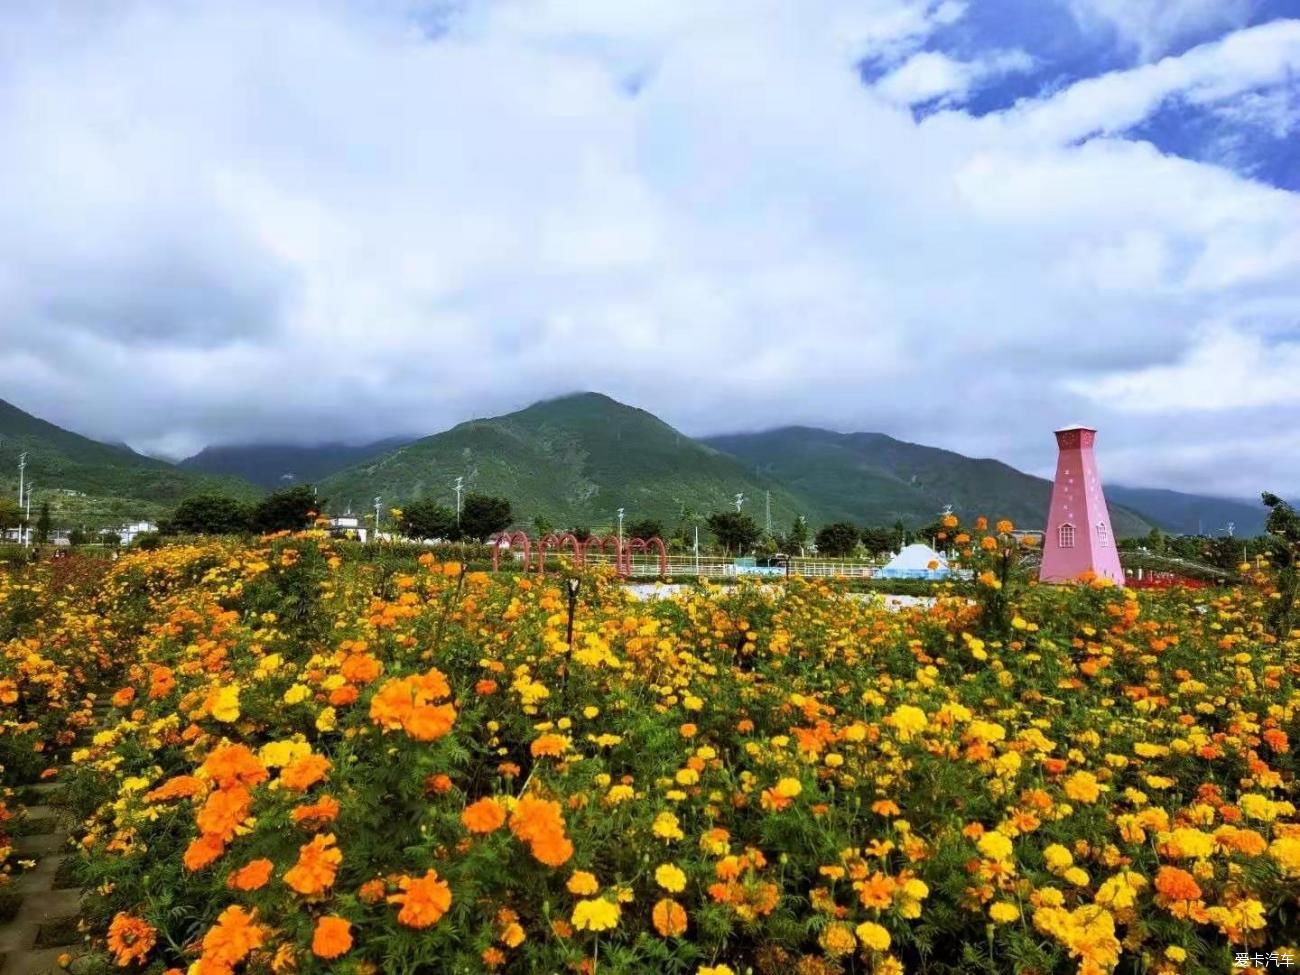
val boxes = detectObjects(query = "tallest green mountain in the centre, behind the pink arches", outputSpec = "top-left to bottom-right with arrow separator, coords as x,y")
320,393 -> 803,528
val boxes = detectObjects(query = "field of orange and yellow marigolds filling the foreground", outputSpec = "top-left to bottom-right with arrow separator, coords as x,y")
0,533 -> 1300,975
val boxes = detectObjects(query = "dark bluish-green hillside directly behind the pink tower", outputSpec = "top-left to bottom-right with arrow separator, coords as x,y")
703,426 -> 1152,536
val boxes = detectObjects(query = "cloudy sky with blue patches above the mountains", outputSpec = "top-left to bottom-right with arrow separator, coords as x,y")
0,0 -> 1300,497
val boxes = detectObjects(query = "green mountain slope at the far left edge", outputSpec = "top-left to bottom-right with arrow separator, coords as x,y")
0,399 -> 259,527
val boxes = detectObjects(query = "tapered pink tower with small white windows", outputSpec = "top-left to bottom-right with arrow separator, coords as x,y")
1039,426 -> 1125,585
